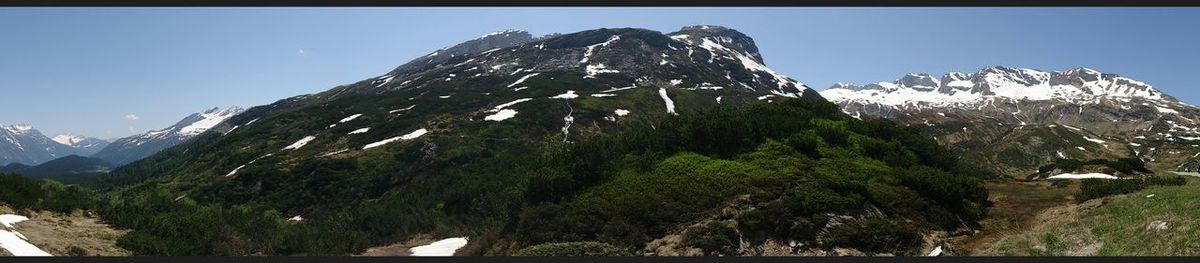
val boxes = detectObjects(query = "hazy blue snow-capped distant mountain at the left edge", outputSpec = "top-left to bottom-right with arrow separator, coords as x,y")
0,125 -> 86,165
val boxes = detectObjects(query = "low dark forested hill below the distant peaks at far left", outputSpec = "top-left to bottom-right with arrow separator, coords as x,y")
0,155 -> 113,184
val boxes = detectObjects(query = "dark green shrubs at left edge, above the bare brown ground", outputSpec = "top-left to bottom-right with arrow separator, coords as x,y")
0,173 -> 100,213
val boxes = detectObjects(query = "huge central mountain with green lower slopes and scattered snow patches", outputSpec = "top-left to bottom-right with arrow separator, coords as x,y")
100,26 -> 986,256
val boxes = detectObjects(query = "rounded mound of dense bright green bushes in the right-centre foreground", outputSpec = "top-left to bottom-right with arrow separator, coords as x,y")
515,100 -> 986,253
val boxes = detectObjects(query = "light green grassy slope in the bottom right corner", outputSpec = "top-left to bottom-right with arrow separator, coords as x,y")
976,175 -> 1200,256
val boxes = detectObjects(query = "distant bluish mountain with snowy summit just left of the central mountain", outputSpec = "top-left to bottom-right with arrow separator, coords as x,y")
91,107 -> 244,166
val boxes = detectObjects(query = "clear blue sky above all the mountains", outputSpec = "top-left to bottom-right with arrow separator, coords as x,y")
0,7 -> 1200,138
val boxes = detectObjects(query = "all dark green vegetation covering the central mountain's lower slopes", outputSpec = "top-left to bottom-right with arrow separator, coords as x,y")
82,78 -> 986,255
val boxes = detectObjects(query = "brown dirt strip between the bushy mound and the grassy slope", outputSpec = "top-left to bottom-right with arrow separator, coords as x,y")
952,180 -> 1079,256
